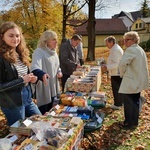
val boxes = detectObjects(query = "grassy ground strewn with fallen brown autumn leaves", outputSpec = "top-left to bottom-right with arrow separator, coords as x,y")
82,50 -> 150,150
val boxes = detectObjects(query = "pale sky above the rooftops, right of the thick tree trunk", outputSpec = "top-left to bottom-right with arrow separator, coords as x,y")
92,0 -> 144,18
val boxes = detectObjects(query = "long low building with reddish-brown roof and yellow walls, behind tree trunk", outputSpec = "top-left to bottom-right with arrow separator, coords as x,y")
74,18 -> 128,47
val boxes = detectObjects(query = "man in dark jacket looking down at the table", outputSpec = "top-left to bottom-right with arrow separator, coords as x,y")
59,34 -> 81,93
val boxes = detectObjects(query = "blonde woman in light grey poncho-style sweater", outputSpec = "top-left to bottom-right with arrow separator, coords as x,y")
31,30 -> 62,114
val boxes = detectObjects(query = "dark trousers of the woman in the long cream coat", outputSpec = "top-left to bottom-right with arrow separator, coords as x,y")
123,93 -> 140,126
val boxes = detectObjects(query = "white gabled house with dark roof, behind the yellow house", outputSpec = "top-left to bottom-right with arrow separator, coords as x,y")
112,11 -> 141,31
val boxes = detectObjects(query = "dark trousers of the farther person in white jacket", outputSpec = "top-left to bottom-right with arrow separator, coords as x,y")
111,76 -> 123,106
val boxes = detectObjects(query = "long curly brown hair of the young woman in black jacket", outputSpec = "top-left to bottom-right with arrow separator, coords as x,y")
0,22 -> 30,66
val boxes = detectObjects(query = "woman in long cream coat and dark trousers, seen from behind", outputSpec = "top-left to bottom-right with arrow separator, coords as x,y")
119,31 -> 149,128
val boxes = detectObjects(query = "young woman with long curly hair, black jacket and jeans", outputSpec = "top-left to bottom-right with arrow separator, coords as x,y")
0,22 -> 41,126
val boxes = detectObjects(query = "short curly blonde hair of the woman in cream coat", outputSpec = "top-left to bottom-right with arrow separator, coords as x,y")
123,31 -> 140,44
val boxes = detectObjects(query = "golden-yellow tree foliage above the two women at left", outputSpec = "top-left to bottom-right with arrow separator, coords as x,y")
2,0 -> 62,38
